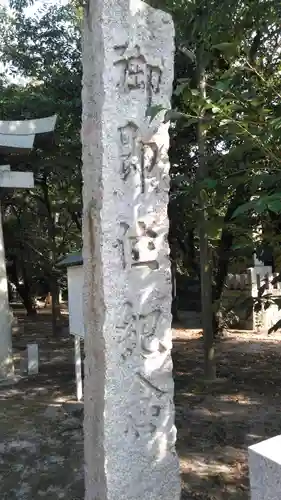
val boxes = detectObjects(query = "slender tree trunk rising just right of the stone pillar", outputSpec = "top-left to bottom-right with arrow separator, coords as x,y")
197,56 -> 216,380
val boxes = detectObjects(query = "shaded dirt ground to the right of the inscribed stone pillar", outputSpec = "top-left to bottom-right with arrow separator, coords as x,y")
174,330 -> 281,500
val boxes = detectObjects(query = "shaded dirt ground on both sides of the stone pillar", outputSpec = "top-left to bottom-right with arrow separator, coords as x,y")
0,316 -> 281,500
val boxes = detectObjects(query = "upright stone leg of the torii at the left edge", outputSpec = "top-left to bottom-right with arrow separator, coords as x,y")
0,207 -> 14,385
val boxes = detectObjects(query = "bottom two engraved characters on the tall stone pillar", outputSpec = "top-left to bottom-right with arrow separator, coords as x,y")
117,301 -> 176,444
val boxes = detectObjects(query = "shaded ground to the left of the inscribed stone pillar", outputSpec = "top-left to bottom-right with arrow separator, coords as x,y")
0,314 -> 84,500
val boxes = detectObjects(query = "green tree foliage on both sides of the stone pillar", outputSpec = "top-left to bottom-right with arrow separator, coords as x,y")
3,0 -> 281,336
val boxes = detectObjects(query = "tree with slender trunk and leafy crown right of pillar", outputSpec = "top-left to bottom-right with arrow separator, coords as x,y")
148,0 -> 280,377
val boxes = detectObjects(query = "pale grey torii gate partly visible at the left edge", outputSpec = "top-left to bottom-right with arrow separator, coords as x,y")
0,115 -> 57,384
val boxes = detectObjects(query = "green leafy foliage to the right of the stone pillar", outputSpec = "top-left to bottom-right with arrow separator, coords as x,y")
151,0 -> 281,340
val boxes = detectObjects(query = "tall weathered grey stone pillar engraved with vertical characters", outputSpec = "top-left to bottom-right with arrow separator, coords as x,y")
82,0 -> 180,500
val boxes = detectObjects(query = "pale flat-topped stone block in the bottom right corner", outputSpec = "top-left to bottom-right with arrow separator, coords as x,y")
249,435 -> 281,500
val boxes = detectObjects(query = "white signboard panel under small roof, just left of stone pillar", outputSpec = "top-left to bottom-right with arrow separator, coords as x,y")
67,266 -> 84,338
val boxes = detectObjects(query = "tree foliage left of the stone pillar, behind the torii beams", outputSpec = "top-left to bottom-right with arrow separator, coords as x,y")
0,2 -> 82,310
